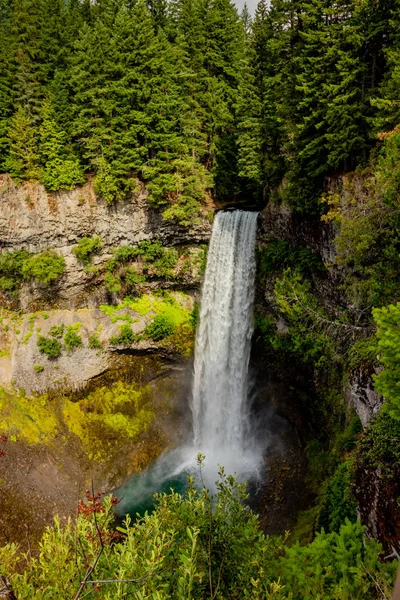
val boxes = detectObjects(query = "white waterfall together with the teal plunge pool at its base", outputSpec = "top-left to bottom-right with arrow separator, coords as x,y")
114,210 -> 265,516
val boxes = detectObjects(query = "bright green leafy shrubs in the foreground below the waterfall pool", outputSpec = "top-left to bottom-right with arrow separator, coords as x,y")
0,455 -> 397,600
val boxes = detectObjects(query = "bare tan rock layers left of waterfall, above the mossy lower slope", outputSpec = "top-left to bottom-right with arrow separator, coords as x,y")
0,176 -> 212,393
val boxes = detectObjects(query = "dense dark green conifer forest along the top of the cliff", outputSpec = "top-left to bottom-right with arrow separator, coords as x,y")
0,0 -> 400,218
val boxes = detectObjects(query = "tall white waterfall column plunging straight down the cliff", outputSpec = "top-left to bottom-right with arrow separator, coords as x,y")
191,210 -> 258,475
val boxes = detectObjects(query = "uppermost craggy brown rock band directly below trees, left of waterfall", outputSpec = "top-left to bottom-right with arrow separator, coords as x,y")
0,175 -> 212,311
